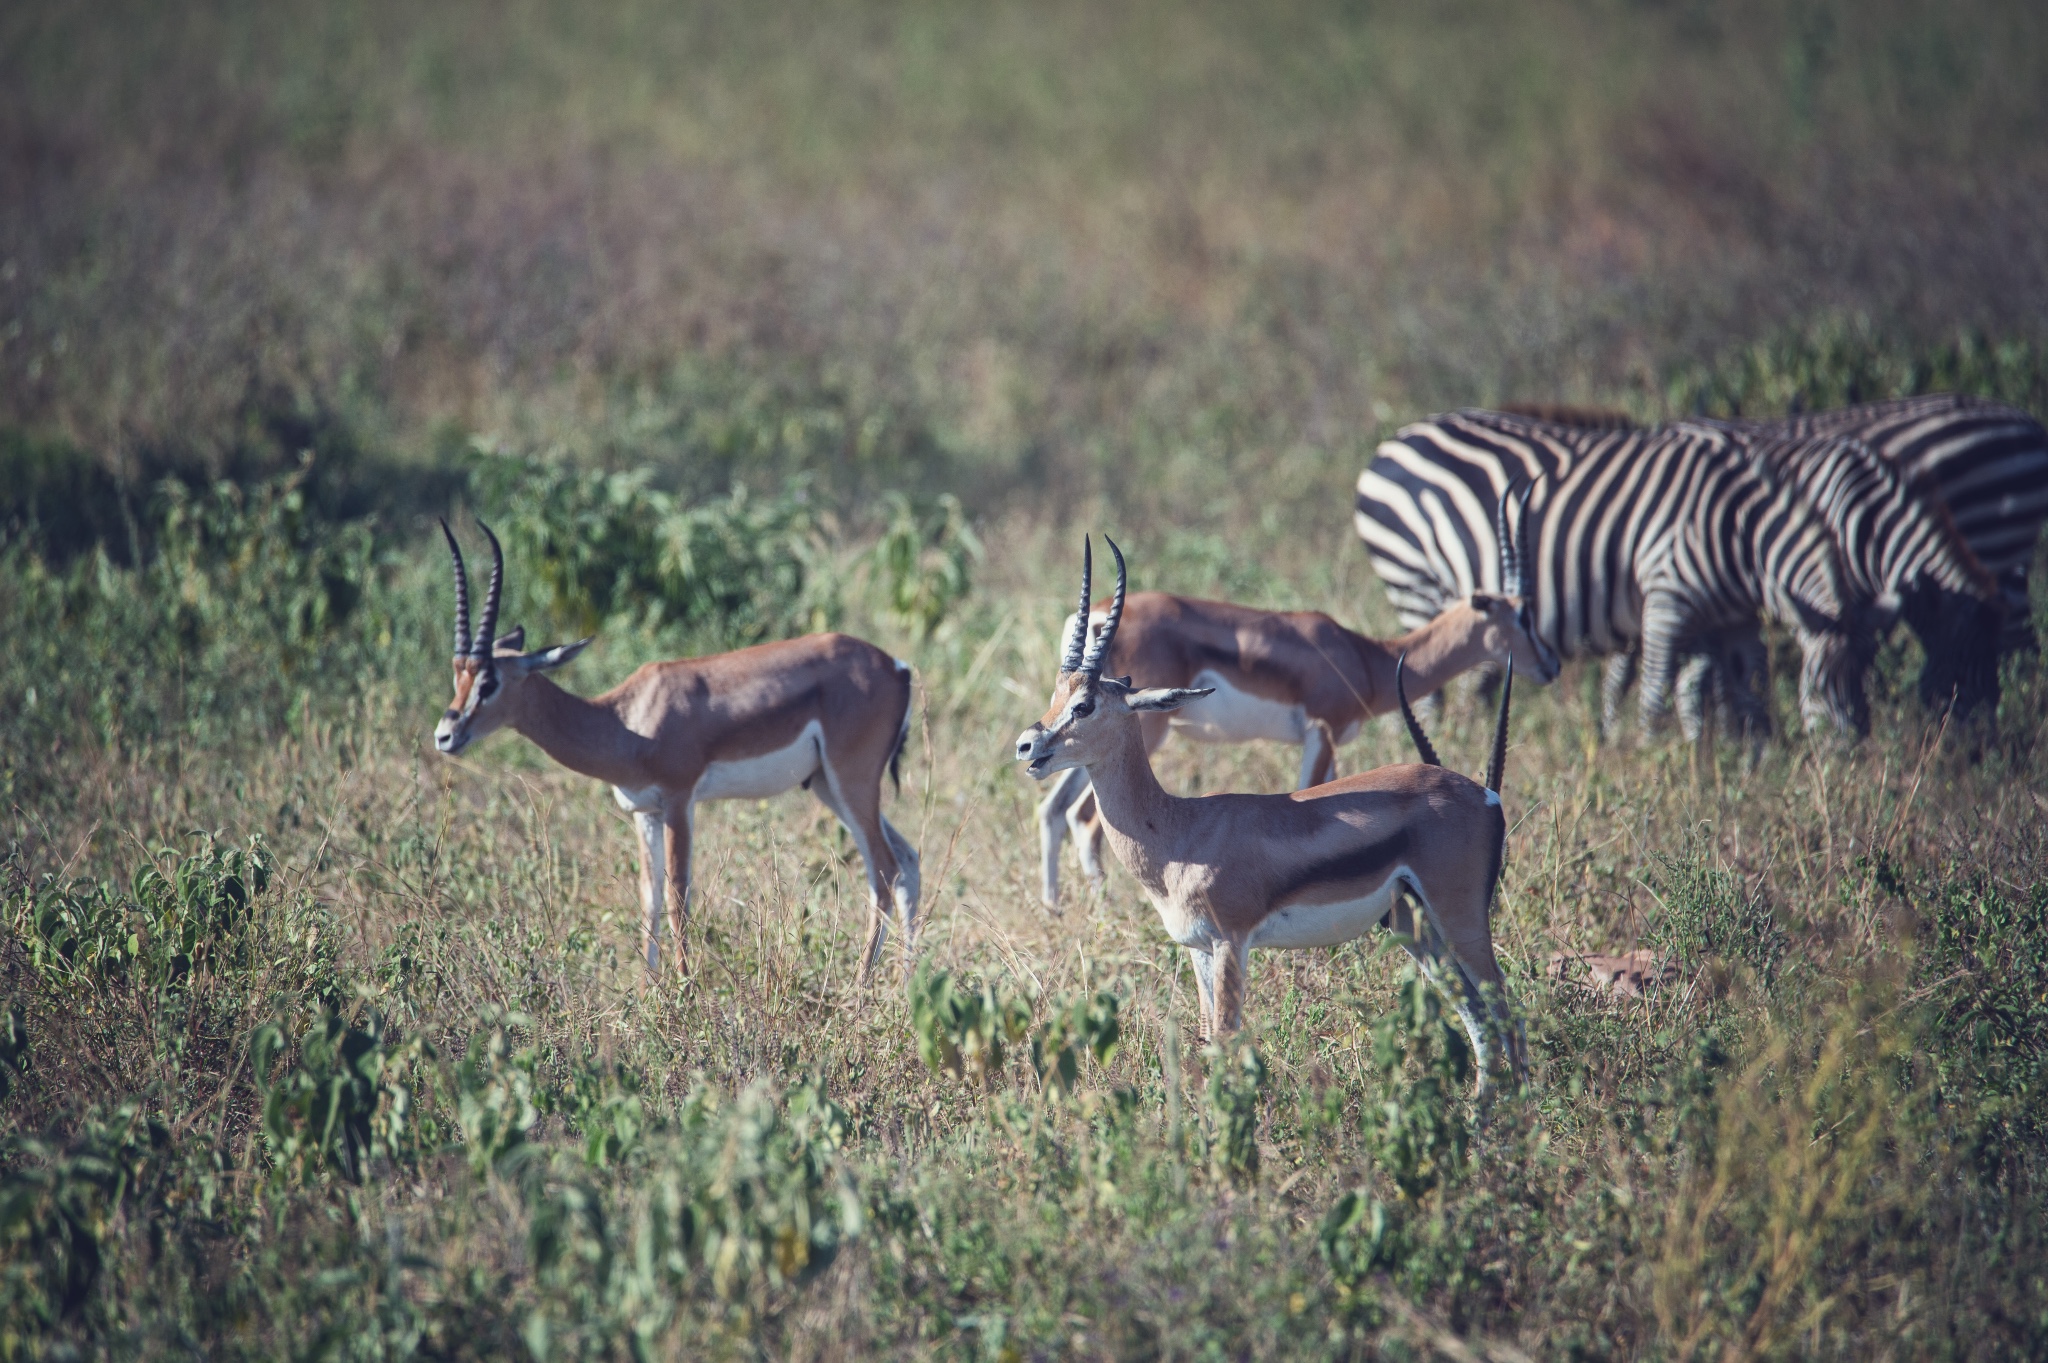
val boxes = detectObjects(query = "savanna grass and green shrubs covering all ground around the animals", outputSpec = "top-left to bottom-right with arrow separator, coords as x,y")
0,0 -> 2048,1359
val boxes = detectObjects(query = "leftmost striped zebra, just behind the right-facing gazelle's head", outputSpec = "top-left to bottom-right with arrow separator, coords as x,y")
1356,411 -> 1868,735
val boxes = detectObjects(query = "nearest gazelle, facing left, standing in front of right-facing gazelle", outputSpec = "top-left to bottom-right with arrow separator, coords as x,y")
1016,540 -> 1524,1093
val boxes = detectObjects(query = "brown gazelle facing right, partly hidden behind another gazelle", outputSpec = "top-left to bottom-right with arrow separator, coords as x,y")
1038,489 -> 1559,909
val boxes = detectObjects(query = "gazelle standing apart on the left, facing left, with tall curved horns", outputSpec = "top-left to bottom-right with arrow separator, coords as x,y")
434,522 -> 918,980
